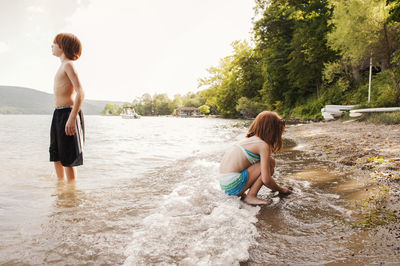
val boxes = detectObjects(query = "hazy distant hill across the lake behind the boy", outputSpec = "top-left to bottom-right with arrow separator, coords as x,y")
0,86 -> 123,115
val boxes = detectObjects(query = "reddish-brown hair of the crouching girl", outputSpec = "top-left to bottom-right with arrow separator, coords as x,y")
246,111 -> 286,152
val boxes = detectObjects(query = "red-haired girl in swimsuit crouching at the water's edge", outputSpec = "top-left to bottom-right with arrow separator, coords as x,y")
219,111 -> 292,205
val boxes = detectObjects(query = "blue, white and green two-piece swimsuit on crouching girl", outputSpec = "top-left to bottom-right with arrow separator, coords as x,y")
219,140 -> 263,196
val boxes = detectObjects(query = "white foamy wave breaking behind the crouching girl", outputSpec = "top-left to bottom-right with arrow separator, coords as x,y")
125,160 -> 260,265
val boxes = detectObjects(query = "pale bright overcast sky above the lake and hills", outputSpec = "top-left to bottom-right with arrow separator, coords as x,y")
0,0 -> 255,101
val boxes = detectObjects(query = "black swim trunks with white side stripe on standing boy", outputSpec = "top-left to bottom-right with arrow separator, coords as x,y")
49,106 -> 84,167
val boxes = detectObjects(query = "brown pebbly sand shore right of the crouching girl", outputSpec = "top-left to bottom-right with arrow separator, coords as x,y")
285,121 -> 400,264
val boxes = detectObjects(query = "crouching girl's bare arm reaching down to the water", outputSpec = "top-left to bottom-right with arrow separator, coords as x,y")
260,144 -> 291,193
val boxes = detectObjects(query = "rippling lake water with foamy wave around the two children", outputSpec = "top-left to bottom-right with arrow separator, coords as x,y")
0,115 -> 394,265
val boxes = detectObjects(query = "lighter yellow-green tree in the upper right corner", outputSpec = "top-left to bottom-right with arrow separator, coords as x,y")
328,0 -> 400,104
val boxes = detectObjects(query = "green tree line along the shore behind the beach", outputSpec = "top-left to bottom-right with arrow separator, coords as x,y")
104,0 -> 400,118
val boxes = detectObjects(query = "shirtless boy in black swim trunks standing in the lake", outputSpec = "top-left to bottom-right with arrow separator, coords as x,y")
49,33 -> 84,181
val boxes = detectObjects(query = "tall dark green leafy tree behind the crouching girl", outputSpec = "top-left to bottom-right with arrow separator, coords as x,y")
254,0 -> 335,110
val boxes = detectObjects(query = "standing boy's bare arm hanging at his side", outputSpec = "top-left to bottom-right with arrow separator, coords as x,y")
65,62 -> 85,136
